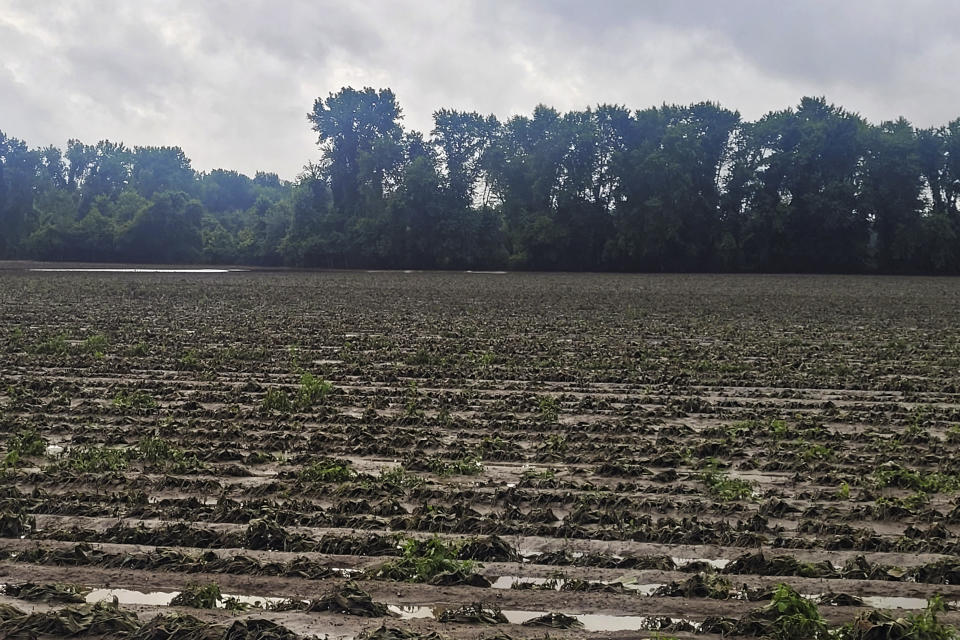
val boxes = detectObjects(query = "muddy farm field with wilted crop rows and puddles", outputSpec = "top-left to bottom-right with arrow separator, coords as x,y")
0,264 -> 960,639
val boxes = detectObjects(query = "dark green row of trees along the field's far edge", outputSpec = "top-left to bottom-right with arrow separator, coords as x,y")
0,87 -> 960,273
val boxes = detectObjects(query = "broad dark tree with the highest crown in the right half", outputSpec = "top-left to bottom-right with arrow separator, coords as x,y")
740,98 -> 870,272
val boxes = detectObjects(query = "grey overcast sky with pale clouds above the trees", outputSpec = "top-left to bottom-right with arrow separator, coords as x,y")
0,0 -> 960,178
